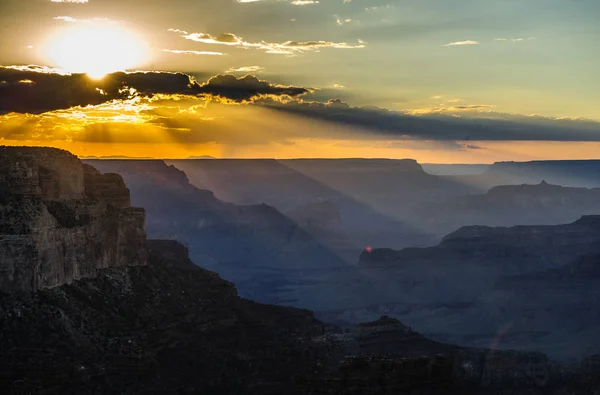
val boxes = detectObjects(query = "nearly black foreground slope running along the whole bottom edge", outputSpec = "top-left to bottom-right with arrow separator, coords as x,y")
0,241 -> 599,394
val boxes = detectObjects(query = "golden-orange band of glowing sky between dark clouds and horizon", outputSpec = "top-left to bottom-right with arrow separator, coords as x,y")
0,95 -> 600,163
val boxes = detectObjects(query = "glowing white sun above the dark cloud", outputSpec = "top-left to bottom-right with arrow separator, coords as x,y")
45,21 -> 148,78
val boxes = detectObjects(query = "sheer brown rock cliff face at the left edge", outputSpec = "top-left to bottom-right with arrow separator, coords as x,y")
0,147 -> 147,293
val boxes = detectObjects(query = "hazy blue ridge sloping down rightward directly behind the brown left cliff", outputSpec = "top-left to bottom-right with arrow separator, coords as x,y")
88,161 -> 343,269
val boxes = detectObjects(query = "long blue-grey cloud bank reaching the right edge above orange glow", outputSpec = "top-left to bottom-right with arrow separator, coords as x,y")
264,99 -> 600,142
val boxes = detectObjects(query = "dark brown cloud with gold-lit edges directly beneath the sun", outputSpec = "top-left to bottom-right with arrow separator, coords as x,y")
0,66 -> 309,114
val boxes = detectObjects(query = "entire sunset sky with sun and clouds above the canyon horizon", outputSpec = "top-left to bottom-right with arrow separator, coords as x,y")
0,0 -> 600,163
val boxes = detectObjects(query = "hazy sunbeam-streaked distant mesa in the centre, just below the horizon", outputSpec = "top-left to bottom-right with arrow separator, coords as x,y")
167,159 -> 440,256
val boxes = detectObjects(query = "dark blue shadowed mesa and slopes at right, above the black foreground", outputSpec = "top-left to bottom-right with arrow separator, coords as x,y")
350,220 -> 600,360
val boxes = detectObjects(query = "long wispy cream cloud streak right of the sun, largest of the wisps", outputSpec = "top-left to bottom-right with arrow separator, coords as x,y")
168,29 -> 366,55
